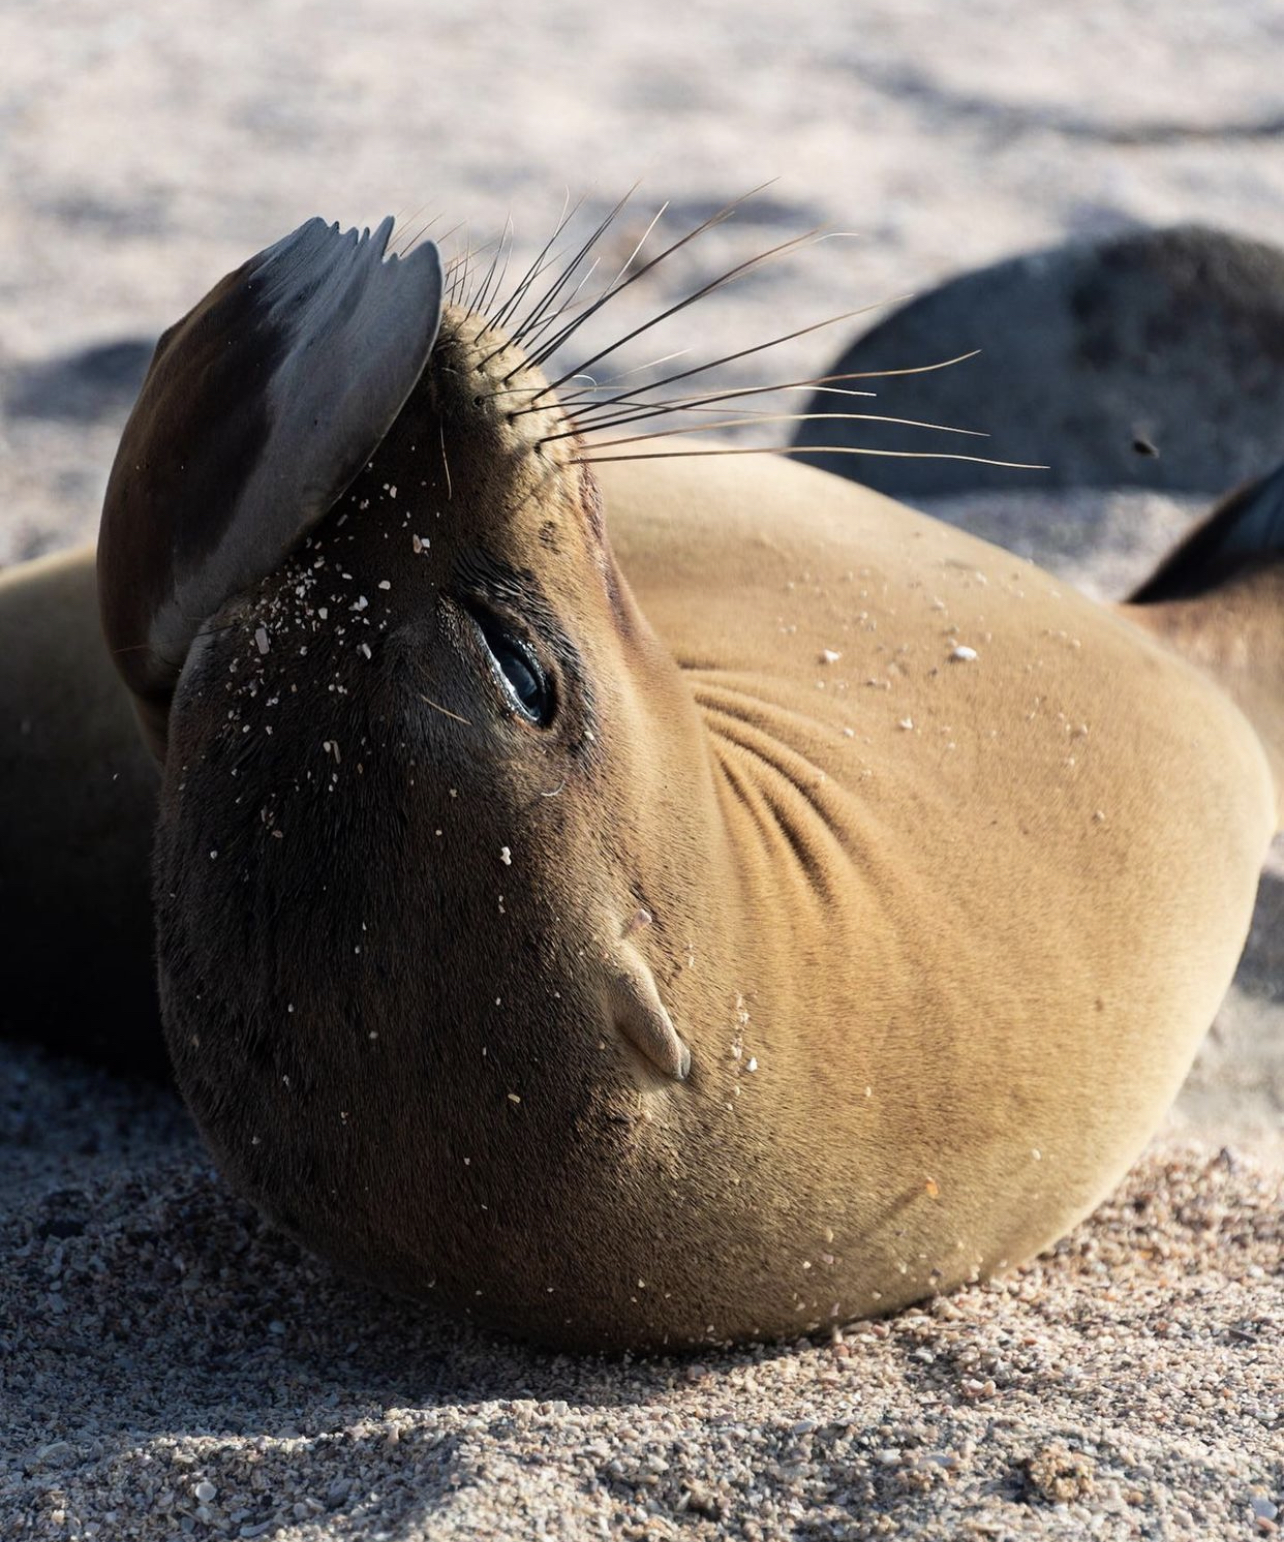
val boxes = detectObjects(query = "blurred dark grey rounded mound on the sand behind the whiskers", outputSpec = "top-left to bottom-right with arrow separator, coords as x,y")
794,225 -> 1284,503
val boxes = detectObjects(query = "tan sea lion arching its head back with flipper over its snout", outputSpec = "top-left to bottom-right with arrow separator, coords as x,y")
50,211 -> 1284,1349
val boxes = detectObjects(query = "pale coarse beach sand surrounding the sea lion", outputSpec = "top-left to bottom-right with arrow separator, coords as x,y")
0,0 -> 1284,1542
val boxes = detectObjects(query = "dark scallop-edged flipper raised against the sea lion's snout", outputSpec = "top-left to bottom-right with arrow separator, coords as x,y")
99,219 -> 442,760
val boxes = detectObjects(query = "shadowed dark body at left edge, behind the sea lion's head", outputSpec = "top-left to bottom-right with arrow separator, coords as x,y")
0,549 -> 165,1072
